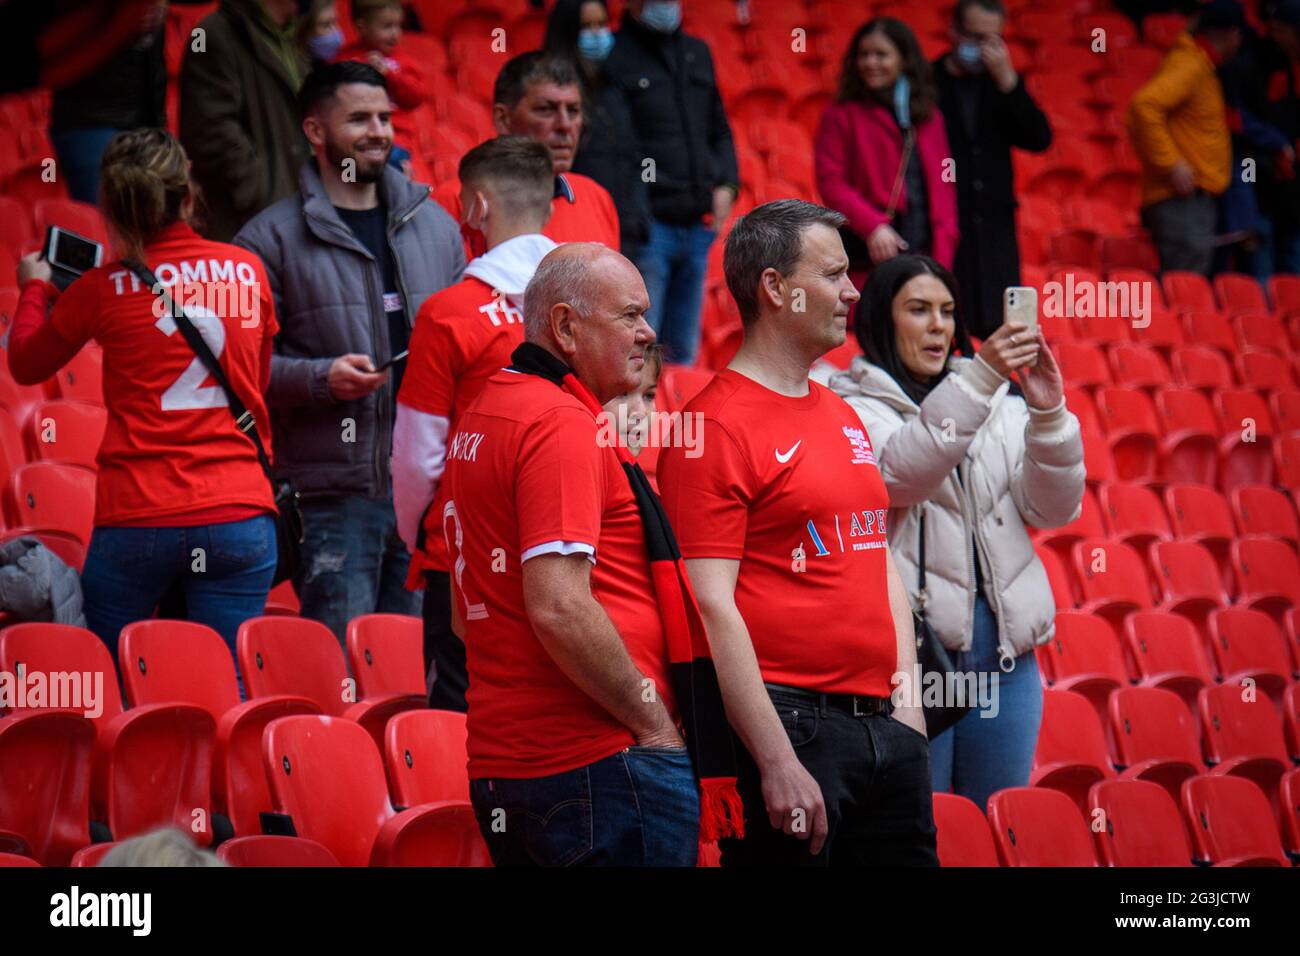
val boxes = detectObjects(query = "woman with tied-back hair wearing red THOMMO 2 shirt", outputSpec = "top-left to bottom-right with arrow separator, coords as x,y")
8,129 -> 277,657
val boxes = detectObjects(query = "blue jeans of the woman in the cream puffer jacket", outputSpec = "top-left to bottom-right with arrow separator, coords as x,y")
930,594 -> 1043,810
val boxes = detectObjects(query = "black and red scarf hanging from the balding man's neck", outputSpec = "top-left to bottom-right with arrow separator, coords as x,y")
510,342 -> 745,843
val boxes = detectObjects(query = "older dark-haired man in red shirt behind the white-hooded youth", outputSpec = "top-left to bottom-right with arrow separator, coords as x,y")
433,51 -> 619,259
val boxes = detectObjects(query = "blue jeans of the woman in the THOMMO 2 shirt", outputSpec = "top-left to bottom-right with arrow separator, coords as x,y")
82,515 -> 280,661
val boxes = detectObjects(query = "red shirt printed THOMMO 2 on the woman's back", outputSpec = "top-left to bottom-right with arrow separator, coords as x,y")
49,222 -> 280,525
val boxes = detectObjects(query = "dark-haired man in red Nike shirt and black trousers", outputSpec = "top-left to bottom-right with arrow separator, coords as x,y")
659,199 -> 937,866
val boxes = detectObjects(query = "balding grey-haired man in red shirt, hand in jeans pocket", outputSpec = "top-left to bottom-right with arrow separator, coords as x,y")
439,243 -> 701,866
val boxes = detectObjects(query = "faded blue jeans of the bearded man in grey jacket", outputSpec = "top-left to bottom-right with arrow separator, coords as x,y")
294,494 -> 424,646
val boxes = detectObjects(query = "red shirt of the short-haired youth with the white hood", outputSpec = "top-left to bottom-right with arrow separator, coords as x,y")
398,276 -> 524,571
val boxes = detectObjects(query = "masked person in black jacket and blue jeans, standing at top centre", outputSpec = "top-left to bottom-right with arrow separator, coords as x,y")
606,0 -> 740,365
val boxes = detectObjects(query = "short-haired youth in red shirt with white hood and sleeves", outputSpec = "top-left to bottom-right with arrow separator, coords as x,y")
393,137 -> 555,713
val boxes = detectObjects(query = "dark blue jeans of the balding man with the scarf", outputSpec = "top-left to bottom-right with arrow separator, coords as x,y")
469,747 -> 699,866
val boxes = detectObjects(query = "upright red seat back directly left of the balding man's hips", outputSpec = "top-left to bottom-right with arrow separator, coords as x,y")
384,710 -> 469,806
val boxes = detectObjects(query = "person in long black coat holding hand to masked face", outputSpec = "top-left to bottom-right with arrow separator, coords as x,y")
933,0 -> 1052,338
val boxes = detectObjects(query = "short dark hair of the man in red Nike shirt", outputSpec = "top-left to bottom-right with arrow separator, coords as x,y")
723,199 -> 848,325
